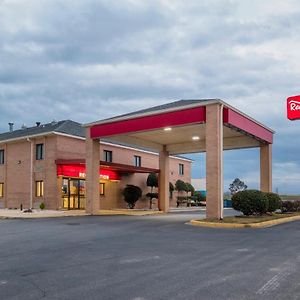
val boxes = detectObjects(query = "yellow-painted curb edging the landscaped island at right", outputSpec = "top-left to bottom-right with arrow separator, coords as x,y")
186,216 -> 300,228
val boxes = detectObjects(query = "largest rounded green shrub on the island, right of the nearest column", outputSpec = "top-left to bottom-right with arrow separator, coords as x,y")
231,190 -> 268,216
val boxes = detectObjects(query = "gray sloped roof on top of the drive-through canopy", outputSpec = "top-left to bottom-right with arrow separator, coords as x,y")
101,99 -> 220,121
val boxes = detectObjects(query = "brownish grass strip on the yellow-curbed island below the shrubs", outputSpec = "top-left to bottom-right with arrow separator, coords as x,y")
197,212 -> 300,224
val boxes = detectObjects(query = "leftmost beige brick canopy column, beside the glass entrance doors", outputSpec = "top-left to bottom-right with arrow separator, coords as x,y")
85,128 -> 100,215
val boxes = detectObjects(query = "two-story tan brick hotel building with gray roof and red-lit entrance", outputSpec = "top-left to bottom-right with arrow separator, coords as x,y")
0,120 -> 192,209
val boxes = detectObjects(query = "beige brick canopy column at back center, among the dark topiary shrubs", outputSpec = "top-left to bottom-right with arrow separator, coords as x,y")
158,146 -> 170,212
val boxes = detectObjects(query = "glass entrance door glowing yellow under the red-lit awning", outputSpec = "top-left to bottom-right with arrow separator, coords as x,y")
62,178 -> 85,209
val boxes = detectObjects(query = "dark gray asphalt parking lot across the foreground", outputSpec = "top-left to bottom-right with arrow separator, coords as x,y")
0,211 -> 300,300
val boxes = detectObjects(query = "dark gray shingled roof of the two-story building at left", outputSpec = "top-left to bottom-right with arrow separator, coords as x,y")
0,120 -> 85,141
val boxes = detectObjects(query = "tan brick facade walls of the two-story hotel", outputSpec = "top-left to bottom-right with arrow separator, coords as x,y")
0,134 -> 191,209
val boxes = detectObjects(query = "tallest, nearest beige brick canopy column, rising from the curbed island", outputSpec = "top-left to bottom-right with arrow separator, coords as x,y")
205,104 -> 223,219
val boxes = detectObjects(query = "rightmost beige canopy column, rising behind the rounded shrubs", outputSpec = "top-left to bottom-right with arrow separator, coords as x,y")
260,144 -> 272,192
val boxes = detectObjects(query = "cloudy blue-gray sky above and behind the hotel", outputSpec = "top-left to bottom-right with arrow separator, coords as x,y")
0,0 -> 300,194
